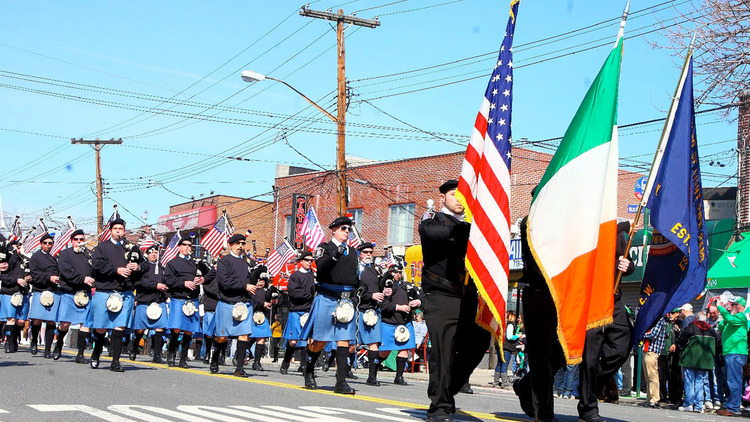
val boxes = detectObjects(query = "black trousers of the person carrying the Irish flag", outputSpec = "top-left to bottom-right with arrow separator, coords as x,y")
517,286 -> 565,420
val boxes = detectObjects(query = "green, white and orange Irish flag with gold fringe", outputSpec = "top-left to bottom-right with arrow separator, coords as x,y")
527,9 -> 627,364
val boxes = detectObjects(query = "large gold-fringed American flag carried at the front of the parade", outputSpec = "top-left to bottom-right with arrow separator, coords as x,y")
456,0 -> 519,341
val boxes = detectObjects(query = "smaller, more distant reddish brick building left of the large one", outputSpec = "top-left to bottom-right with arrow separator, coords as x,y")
156,195 -> 274,255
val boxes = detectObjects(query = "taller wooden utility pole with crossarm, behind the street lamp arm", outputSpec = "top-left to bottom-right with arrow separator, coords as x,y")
299,6 -> 380,216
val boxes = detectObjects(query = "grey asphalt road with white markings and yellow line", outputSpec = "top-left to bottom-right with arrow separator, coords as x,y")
0,347 -> 744,422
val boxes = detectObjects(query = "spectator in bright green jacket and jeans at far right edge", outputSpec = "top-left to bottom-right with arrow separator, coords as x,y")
716,297 -> 750,416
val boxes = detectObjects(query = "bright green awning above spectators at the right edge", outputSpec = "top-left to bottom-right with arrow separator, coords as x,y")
706,232 -> 750,289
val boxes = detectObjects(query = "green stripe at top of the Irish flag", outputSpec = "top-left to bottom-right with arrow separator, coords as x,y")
532,37 -> 622,203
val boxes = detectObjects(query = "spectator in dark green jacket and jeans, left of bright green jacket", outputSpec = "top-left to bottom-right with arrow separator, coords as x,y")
677,311 -> 720,413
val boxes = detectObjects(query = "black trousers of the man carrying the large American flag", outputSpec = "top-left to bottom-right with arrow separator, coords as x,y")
422,288 -> 491,416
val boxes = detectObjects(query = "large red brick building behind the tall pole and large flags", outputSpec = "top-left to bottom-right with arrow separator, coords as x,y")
274,148 -> 642,254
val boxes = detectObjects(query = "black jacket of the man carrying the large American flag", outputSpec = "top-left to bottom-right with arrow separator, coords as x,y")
419,211 -> 471,294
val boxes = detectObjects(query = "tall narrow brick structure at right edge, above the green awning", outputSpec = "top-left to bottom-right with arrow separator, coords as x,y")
737,91 -> 750,231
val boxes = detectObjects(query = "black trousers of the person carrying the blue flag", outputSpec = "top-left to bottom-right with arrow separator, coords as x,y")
578,298 -> 633,420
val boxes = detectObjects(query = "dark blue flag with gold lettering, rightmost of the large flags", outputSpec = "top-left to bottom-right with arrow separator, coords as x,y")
633,56 -> 708,344
